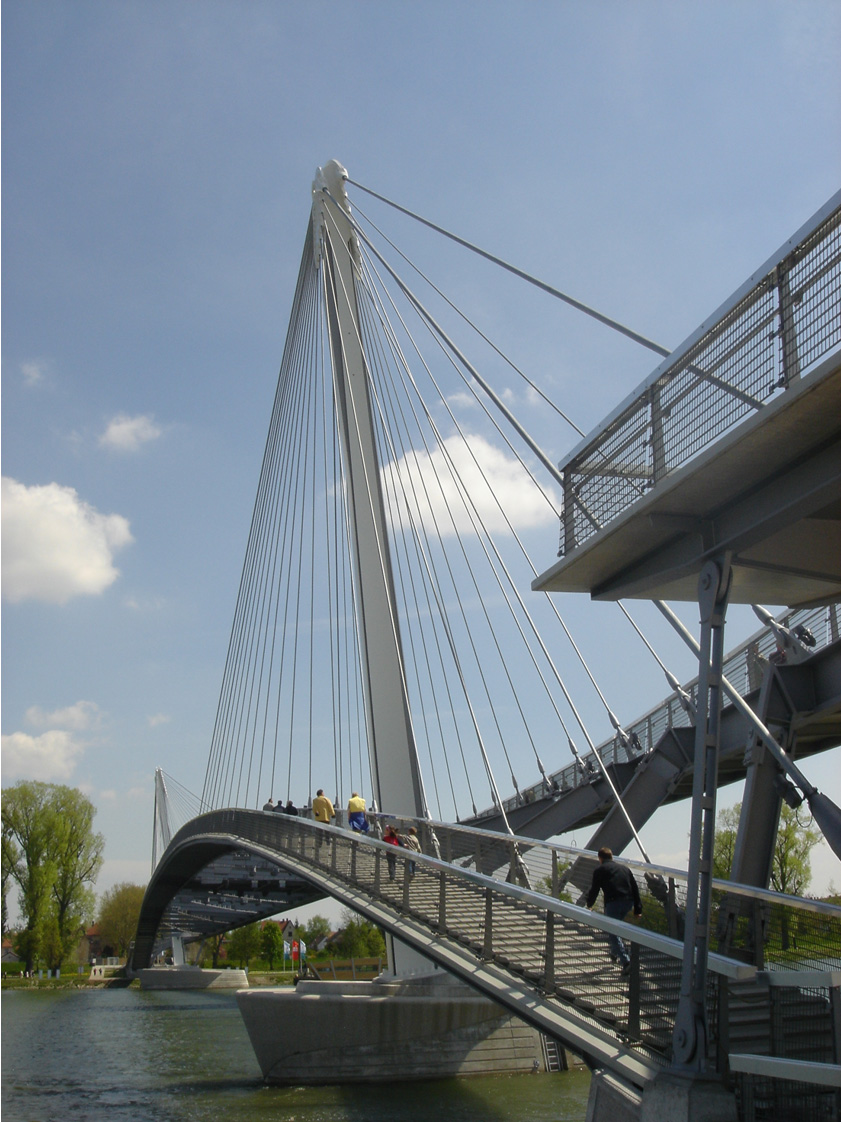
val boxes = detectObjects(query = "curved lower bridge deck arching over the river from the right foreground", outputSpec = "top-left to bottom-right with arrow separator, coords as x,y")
135,810 -> 841,1086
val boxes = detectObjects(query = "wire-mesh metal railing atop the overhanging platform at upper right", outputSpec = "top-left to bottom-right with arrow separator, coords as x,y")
558,192 -> 841,557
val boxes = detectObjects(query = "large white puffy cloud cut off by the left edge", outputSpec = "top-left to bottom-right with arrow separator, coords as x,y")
2,477 -> 133,604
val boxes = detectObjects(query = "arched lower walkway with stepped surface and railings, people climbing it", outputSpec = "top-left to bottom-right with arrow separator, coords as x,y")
132,809 -> 841,1086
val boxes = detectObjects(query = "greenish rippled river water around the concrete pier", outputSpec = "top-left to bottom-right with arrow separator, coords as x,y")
0,988 -> 590,1122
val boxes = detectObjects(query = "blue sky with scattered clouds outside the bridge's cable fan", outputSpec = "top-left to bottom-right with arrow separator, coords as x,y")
2,0 -> 841,929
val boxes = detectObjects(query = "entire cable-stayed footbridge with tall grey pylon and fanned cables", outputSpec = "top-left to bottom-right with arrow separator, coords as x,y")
133,164 -> 841,1116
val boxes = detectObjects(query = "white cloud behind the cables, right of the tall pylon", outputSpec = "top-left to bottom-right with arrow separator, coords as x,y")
383,436 -> 556,536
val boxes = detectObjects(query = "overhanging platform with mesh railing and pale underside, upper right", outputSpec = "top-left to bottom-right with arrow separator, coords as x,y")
533,192 -> 841,607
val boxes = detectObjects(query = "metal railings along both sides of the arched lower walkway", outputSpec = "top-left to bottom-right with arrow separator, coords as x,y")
154,809 -> 841,1090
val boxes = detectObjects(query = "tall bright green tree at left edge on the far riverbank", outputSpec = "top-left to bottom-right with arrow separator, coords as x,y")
2,781 -> 104,969
